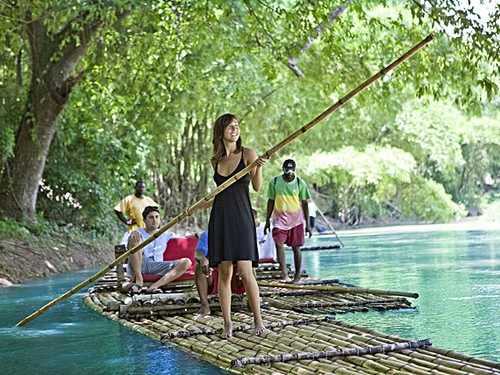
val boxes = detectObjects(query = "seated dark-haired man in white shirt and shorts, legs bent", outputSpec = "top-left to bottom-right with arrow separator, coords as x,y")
127,206 -> 191,294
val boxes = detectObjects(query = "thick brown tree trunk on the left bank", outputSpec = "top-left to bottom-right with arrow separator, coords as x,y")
0,7 -> 125,222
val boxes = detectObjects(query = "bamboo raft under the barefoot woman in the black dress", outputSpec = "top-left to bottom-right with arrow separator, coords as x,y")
84,264 -> 500,375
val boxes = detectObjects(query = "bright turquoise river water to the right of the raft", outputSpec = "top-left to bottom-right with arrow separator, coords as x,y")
300,225 -> 500,362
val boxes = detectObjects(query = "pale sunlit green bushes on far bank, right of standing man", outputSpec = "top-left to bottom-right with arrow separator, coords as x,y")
299,146 -> 464,222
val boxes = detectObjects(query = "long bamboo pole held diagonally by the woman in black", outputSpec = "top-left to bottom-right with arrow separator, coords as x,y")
16,34 -> 434,327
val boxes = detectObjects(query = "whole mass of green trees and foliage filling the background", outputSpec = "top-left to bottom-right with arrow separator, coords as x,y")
0,0 -> 500,235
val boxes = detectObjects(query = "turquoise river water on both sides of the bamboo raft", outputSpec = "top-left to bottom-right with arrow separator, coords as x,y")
0,225 -> 500,375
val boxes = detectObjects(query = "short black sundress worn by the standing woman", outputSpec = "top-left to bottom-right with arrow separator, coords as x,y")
208,150 -> 259,267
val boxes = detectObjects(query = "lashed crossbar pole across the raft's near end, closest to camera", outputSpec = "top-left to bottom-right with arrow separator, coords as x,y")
231,339 -> 432,367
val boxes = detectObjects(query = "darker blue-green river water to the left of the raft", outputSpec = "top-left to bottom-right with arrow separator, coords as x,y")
0,269 -> 224,375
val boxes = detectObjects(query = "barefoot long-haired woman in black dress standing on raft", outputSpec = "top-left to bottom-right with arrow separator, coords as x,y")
208,114 -> 267,338
